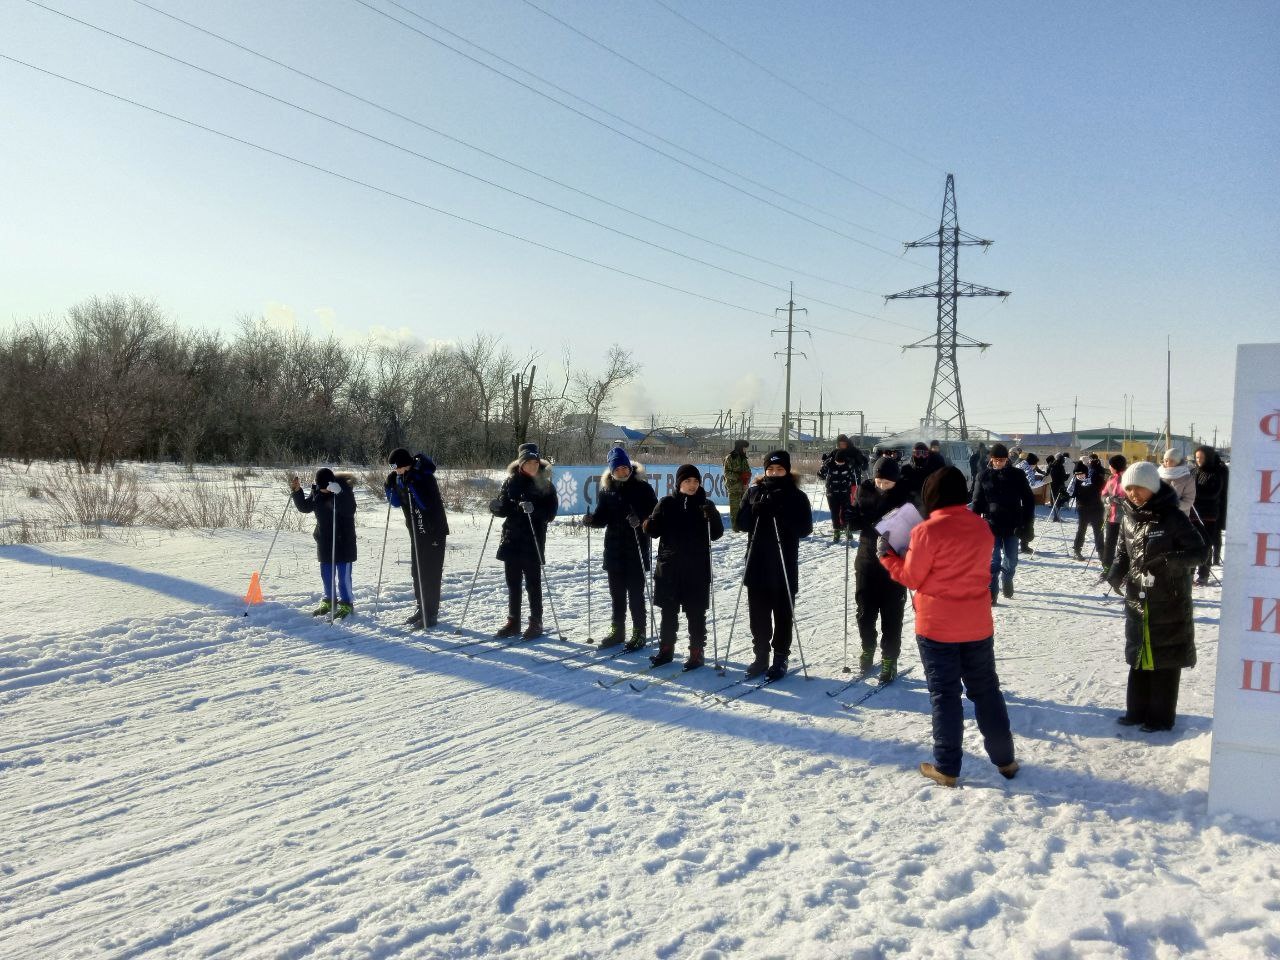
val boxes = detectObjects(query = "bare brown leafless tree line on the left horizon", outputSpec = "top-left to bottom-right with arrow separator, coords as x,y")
0,296 -> 639,472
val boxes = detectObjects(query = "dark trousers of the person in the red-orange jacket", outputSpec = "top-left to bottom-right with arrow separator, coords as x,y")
915,636 -> 1014,777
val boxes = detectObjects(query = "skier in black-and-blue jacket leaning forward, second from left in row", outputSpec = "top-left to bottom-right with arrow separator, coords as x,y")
385,447 -> 449,630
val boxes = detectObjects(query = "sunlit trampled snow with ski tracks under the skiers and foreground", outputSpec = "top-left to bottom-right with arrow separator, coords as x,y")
0,463 -> 1280,960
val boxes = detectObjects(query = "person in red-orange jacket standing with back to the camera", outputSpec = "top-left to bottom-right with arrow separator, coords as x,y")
877,467 -> 1018,787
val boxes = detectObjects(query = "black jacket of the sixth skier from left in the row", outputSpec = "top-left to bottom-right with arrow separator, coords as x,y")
737,474 -> 813,596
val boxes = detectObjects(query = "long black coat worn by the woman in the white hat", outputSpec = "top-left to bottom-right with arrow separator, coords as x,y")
1107,483 -> 1208,669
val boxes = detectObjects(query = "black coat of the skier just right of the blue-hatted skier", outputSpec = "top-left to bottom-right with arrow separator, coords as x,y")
644,486 -> 724,611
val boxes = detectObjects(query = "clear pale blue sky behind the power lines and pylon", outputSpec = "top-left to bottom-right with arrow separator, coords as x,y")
0,0 -> 1280,434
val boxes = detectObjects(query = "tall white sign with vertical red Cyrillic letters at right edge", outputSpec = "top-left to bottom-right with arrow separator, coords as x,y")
1208,344 -> 1280,820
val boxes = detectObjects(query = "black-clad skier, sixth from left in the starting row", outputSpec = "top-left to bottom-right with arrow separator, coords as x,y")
737,451 -> 813,680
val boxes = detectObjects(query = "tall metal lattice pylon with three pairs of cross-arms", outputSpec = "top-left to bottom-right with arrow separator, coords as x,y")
884,173 -> 1009,440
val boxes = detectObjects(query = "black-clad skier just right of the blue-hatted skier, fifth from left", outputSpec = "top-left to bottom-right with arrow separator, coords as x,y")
644,463 -> 724,669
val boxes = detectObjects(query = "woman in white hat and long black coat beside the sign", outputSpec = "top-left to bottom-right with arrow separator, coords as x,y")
1108,461 -> 1208,732
